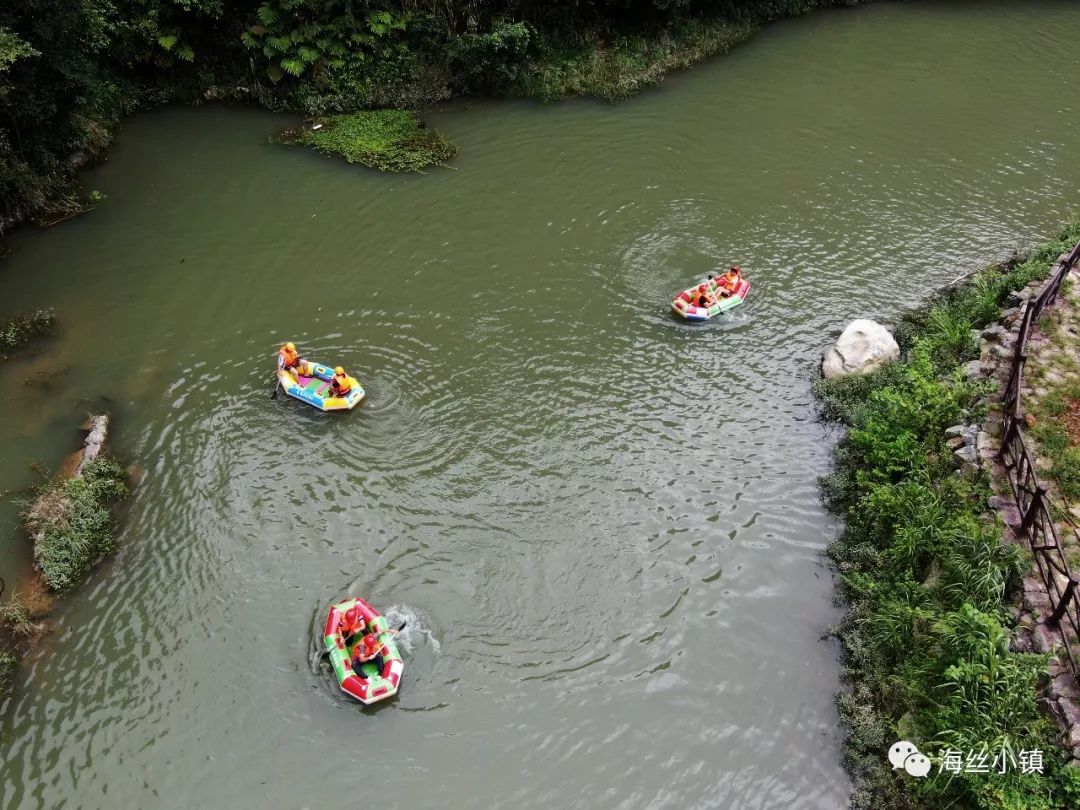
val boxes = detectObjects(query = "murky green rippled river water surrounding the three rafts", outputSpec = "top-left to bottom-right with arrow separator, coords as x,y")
0,2 -> 1080,810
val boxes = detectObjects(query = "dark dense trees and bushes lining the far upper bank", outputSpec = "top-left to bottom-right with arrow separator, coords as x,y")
0,0 -> 863,226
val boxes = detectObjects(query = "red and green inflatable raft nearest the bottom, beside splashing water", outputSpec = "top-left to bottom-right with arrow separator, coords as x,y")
323,597 -> 405,704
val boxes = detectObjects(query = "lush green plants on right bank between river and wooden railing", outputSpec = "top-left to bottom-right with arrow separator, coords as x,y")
816,227 -> 1080,810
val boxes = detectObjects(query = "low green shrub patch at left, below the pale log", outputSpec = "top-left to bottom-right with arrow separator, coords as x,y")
25,458 -> 127,593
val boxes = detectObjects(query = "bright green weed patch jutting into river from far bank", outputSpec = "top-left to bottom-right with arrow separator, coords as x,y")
294,110 -> 458,172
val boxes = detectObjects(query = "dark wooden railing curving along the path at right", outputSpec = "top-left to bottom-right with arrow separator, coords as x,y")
998,242 -> 1080,678
